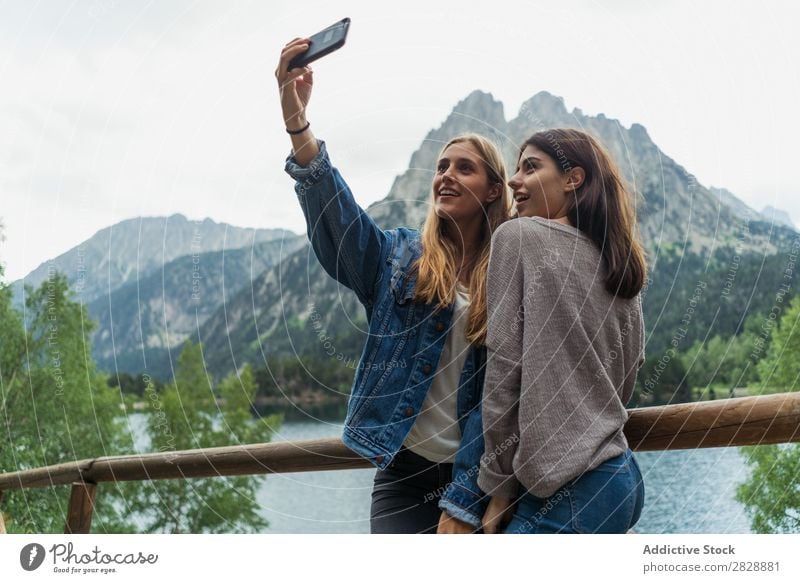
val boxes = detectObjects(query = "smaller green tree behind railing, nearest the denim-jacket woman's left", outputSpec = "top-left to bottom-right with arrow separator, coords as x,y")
126,341 -> 281,533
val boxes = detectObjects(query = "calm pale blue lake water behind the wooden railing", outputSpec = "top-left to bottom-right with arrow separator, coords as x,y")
125,413 -> 751,533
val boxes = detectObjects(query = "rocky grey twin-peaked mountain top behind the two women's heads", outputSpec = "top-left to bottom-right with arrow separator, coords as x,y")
368,91 -> 791,251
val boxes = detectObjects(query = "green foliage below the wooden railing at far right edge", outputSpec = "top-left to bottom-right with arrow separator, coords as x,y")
736,444 -> 800,533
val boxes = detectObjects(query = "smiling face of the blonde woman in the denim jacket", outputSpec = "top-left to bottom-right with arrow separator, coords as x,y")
433,142 -> 502,223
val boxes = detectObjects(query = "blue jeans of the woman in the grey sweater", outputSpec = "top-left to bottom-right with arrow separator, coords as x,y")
505,449 -> 644,534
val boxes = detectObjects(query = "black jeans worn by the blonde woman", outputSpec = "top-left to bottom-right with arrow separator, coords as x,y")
370,448 -> 453,534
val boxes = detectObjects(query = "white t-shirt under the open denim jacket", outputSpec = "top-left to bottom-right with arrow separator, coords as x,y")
404,285 -> 469,463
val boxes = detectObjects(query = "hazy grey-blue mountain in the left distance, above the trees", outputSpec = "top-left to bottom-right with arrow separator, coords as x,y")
11,214 -> 305,379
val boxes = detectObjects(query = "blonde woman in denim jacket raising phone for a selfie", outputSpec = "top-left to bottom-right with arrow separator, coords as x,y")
275,39 -> 512,533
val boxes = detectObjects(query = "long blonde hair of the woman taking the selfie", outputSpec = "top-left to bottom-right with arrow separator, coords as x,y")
415,134 -> 513,345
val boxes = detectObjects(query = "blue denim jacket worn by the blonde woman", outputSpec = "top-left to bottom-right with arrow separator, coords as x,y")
286,141 -> 488,527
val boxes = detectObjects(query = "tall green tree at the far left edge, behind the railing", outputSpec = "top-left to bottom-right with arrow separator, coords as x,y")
0,271 -> 132,533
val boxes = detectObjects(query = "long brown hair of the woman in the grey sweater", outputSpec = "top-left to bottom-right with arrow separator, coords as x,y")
520,128 -> 647,298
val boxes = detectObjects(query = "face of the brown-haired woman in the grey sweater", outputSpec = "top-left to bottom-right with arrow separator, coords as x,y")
508,145 -> 582,219
